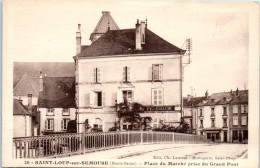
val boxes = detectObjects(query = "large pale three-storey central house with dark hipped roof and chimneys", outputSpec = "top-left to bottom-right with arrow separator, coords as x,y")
74,13 -> 185,133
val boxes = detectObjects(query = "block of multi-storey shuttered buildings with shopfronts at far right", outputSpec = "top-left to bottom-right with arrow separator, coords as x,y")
197,89 -> 248,142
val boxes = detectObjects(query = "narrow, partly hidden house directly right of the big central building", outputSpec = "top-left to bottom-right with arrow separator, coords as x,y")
183,93 -> 207,134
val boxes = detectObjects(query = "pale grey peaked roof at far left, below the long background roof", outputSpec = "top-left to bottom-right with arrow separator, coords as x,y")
13,73 -> 39,97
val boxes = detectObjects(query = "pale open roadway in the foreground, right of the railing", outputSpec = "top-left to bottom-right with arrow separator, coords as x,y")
71,144 -> 248,160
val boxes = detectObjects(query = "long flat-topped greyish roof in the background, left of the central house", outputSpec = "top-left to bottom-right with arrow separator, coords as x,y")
13,62 -> 75,89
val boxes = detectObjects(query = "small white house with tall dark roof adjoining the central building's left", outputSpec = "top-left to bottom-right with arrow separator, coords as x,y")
38,77 -> 76,134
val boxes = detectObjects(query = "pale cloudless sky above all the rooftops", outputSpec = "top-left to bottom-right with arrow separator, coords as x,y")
3,0 -> 253,96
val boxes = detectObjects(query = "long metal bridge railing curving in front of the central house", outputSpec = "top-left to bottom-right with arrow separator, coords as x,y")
13,131 -> 206,158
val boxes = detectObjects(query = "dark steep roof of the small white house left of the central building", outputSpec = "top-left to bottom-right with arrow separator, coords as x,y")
38,77 -> 76,108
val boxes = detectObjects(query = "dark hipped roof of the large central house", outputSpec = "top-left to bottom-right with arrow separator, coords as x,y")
78,28 -> 185,57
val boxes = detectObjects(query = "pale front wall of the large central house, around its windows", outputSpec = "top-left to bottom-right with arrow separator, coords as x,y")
76,55 -> 181,132
